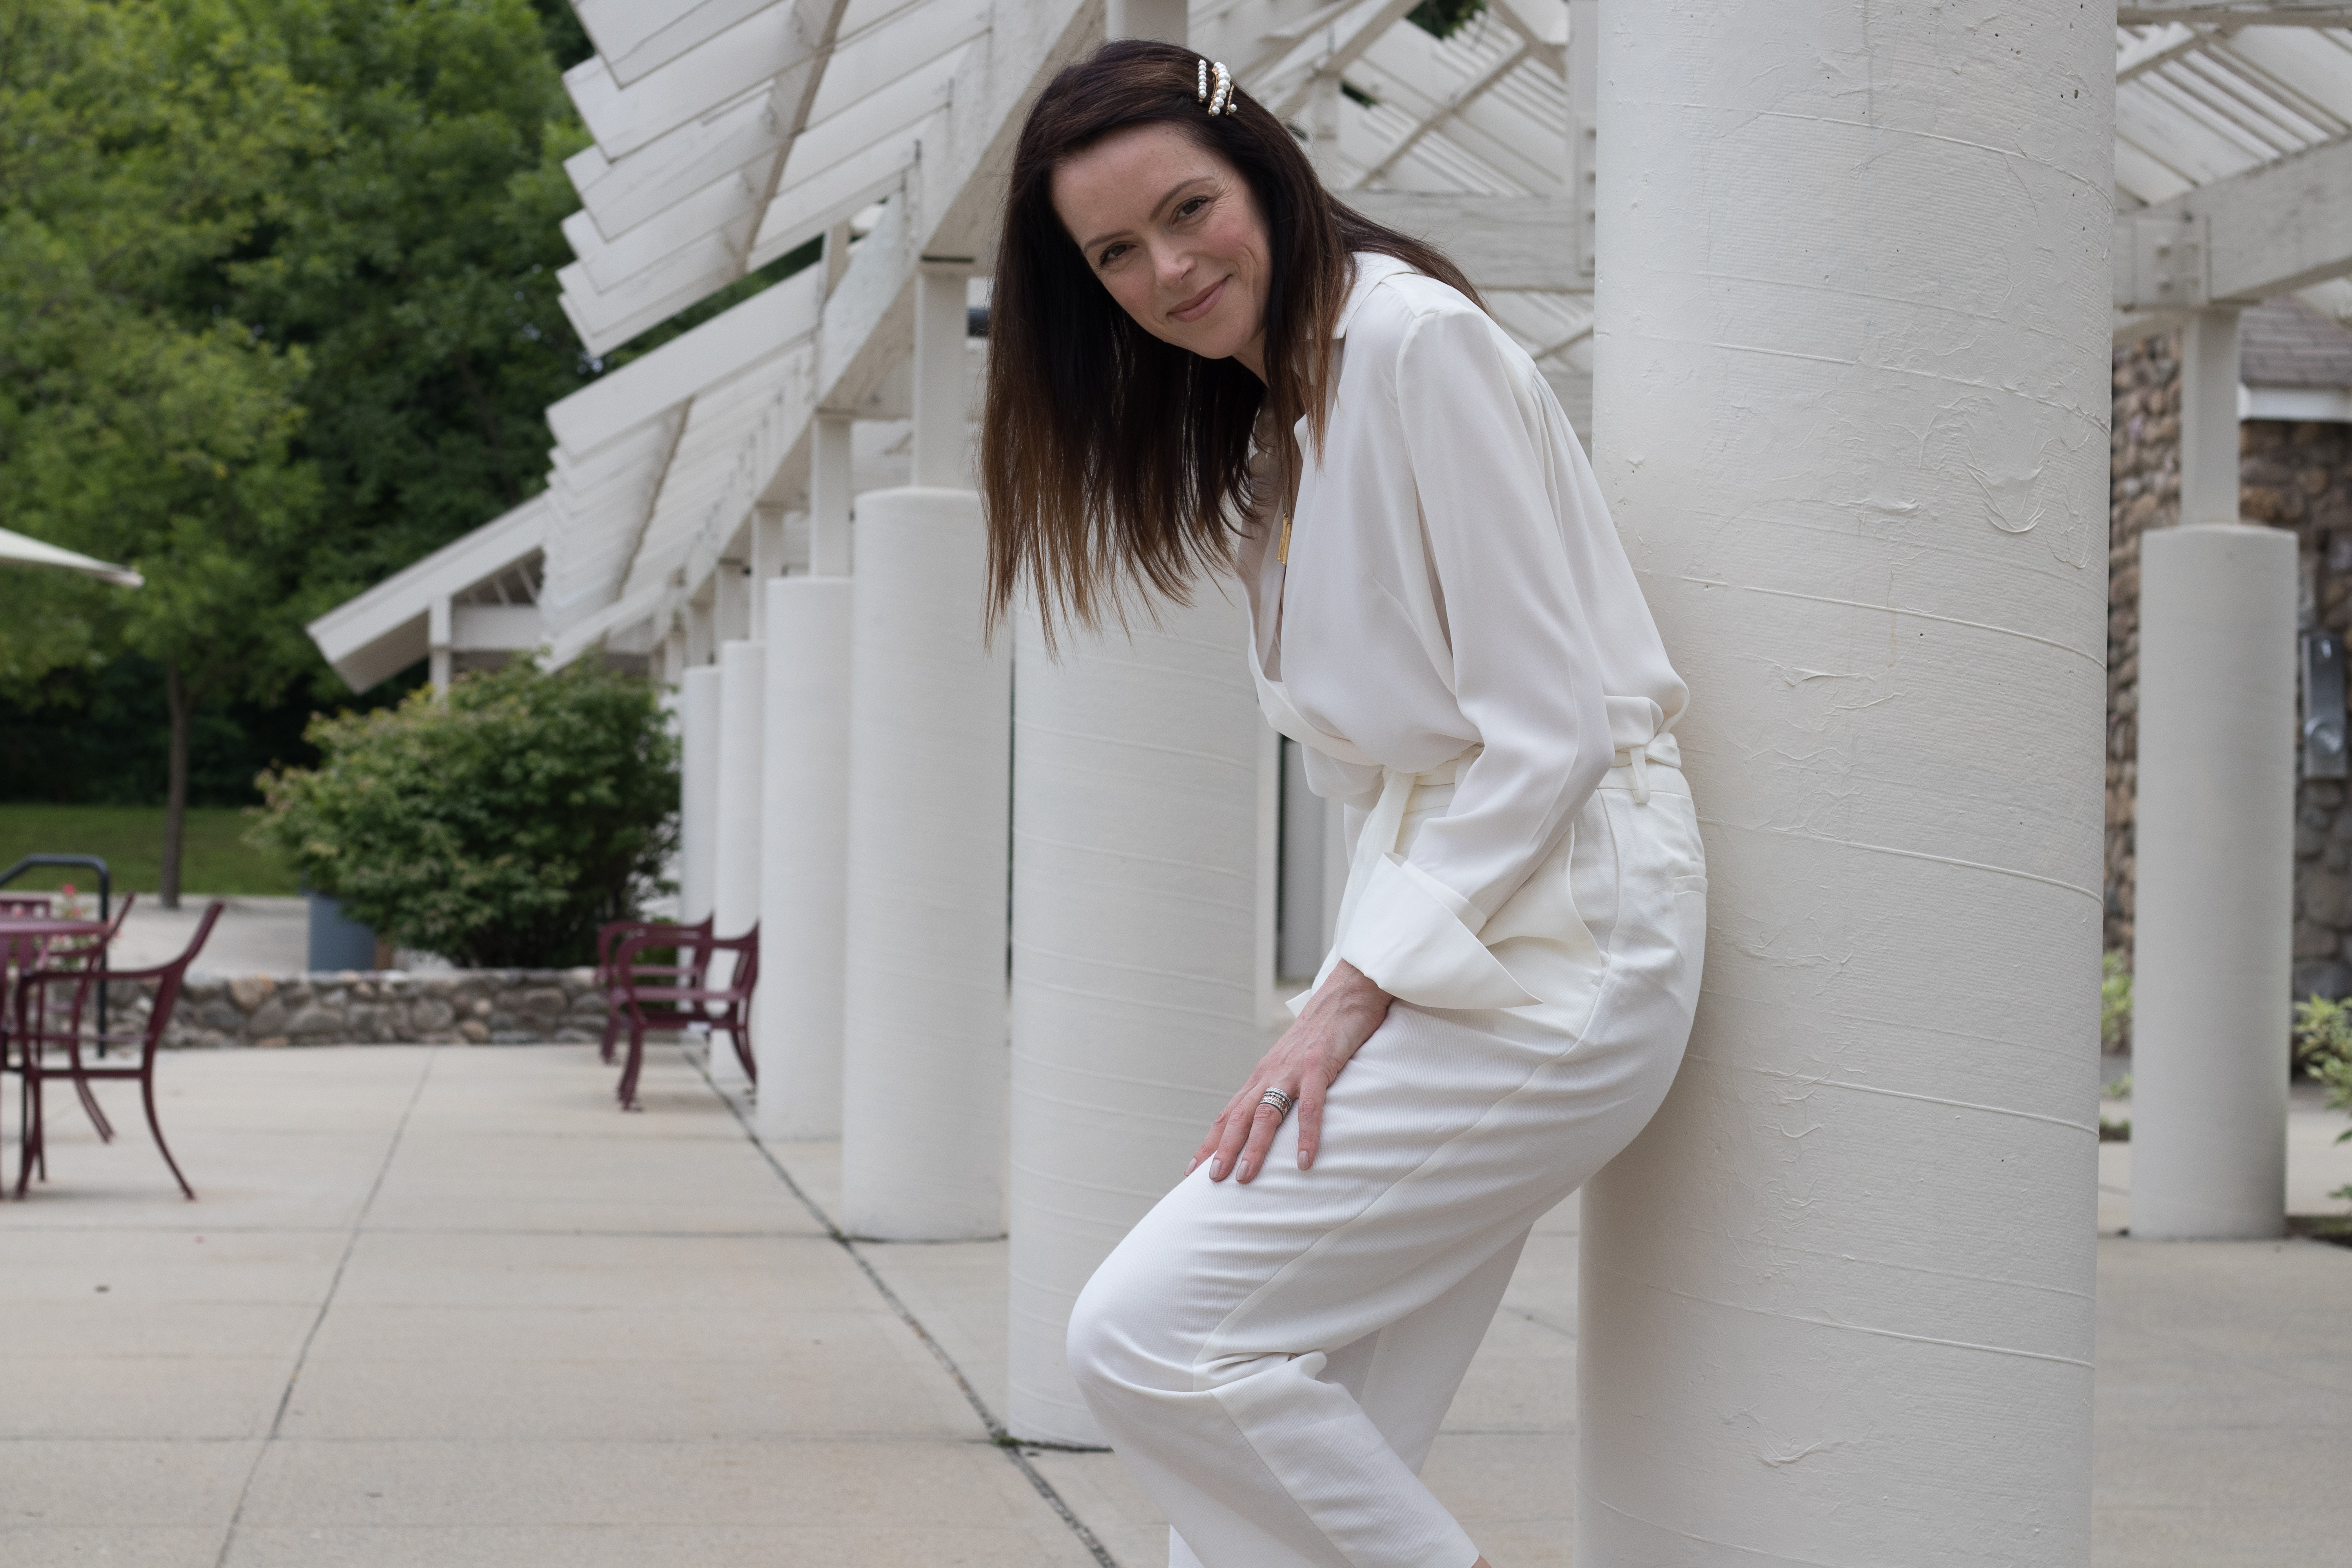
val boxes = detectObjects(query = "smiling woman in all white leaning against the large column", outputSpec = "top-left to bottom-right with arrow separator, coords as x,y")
981,42 -> 1705,1568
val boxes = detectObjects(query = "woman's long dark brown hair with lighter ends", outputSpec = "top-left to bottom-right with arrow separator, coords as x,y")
981,40 -> 1477,642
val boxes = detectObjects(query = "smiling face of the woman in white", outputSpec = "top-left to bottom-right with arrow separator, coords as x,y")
1054,122 -> 1272,381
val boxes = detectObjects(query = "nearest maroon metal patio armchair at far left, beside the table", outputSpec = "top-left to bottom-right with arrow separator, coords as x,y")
0,898 -> 226,1199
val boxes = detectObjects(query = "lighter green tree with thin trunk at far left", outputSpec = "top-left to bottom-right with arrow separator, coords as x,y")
0,0 -> 327,903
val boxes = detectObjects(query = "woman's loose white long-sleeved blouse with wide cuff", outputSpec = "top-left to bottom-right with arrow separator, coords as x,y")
1237,254 -> 1689,1006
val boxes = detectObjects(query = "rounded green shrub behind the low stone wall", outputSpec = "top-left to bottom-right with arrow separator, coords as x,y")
252,658 -> 677,969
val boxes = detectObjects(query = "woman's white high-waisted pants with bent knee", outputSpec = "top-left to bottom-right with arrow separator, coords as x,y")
1070,750 -> 1705,1568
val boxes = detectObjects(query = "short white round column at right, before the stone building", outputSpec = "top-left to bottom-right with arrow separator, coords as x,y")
2131,526 -> 2296,1241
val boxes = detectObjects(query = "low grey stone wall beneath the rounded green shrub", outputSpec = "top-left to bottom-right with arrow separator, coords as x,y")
108,969 -> 604,1049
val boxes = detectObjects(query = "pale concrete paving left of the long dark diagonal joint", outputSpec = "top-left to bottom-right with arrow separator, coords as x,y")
0,1046 -> 1096,1568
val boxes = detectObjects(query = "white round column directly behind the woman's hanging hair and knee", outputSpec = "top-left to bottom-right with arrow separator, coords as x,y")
1007,583 -> 1265,1443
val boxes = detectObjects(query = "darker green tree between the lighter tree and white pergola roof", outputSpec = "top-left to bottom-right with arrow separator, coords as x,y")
226,0 -> 600,583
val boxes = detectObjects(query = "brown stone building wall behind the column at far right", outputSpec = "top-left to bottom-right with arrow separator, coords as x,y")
2107,336 -> 2352,997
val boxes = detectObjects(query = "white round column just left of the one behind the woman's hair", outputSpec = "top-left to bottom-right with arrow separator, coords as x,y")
842,489 -> 1011,1241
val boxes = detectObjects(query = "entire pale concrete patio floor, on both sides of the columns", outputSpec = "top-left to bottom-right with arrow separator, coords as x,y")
0,1046 -> 2352,1568
